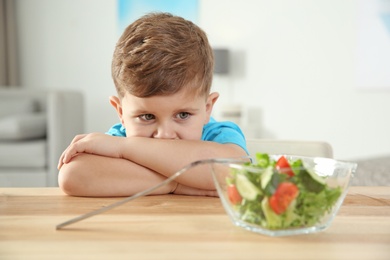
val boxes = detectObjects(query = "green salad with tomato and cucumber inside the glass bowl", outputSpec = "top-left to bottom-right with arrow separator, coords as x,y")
226,153 -> 341,229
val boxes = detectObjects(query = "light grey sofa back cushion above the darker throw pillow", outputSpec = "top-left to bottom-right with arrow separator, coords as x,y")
0,97 -> 37,118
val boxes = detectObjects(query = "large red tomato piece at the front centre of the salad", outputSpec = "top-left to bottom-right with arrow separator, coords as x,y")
269,182 -> 299,215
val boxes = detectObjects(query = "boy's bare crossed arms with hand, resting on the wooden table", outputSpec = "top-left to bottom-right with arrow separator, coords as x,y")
58,133 -> 246,196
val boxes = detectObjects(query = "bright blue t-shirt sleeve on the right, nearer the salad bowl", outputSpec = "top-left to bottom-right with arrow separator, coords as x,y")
202,121 -> 249,154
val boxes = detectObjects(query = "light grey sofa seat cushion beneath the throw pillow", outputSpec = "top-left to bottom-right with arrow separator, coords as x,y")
0,139 -> 47,168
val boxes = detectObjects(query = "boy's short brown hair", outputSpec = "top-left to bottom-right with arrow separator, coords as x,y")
112,13 -> 214,97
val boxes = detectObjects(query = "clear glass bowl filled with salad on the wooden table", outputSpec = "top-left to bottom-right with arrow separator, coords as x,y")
210,154 -> 357,236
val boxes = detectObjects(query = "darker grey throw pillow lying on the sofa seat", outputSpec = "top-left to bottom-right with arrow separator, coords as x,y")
0,112 -> 46,141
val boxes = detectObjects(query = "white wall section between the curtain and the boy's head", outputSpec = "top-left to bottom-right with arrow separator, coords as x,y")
16,0 -> 117,132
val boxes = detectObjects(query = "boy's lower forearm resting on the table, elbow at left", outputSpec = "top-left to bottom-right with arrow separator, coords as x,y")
58,154 -> 176,197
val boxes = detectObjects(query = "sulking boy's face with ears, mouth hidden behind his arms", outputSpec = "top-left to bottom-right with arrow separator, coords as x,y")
110,88 -> 219,140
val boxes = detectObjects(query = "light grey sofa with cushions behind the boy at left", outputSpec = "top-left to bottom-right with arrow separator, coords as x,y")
0,87 -> 84,187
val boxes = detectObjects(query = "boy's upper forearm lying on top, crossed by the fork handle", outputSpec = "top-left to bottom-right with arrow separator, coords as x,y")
121,137 -> 246,190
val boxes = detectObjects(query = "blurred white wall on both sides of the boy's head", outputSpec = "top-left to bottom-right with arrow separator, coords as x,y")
17,0 -> 390,159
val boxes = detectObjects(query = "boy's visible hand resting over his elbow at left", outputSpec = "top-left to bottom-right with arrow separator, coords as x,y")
57,133 -> 123,169
